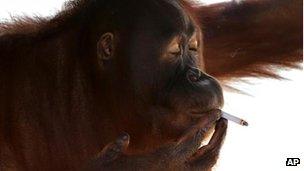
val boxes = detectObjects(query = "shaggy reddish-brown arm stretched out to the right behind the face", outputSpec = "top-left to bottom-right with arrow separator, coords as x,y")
196,0 -> 303,80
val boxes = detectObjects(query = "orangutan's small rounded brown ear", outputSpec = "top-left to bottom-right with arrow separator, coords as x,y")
97,32 -> 114,63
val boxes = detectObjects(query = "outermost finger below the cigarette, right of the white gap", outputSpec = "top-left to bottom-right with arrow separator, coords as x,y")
188,118 -> 227,164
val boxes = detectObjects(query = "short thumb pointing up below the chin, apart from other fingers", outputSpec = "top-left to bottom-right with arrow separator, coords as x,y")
98,133 -> 130,162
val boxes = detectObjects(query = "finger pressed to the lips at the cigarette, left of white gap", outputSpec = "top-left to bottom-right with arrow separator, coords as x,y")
175,110 -> 221,157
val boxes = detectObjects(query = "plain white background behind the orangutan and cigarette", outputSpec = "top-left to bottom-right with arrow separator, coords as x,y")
0,0 -> 304,171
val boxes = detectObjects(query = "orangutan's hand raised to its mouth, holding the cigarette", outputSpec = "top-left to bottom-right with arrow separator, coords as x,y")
85,113 -> 227,171
